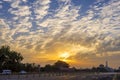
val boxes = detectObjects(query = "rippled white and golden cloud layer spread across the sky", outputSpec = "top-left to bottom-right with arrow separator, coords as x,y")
0,0 -> 120,66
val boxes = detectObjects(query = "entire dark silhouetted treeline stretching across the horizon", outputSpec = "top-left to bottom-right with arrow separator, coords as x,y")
0,46 -> 120,72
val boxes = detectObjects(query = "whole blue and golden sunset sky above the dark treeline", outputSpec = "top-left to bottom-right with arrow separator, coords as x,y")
0,0 -> 120,68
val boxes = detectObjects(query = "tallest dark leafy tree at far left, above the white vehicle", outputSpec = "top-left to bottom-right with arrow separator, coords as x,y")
0,46 -> 23,71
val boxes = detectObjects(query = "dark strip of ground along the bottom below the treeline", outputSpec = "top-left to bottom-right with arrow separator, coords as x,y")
0,73 -> 120,80
